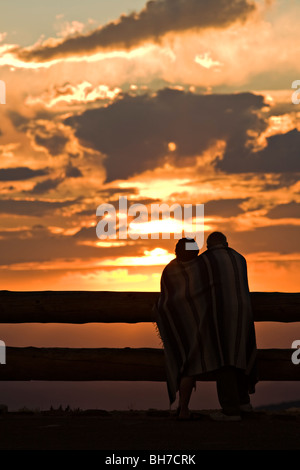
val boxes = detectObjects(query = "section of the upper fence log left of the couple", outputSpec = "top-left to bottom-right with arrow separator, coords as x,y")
0,291 -> 158,324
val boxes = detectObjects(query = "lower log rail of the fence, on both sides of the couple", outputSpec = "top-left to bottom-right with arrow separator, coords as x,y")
0,347 -> 300,382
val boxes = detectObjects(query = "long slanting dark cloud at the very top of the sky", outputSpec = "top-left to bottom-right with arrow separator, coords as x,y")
14,0 -> 256,61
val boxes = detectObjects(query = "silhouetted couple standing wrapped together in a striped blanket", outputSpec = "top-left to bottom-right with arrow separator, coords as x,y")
156,232 -> 257,421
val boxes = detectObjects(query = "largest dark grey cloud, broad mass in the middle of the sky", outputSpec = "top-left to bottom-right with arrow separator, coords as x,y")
65,88 -> 267,181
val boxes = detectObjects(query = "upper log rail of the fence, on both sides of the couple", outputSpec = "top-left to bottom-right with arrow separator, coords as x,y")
0,291 -> 300,324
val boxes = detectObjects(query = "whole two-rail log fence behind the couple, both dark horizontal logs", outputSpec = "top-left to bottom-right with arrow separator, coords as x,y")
0,291 -> 300,382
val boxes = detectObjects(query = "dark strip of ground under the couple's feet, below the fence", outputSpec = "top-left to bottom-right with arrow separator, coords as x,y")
0,409 -> 300,451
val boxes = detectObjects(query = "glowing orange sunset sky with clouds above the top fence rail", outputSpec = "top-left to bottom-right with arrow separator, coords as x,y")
0,0 -> 300,292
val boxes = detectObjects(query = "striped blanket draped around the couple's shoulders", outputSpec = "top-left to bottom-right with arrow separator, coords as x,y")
154,245 -> 257,404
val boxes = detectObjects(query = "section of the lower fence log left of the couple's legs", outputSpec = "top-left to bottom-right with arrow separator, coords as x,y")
0,347 -> 165,381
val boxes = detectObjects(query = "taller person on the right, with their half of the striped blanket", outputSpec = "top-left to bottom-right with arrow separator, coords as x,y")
203,232 -> 256,420
